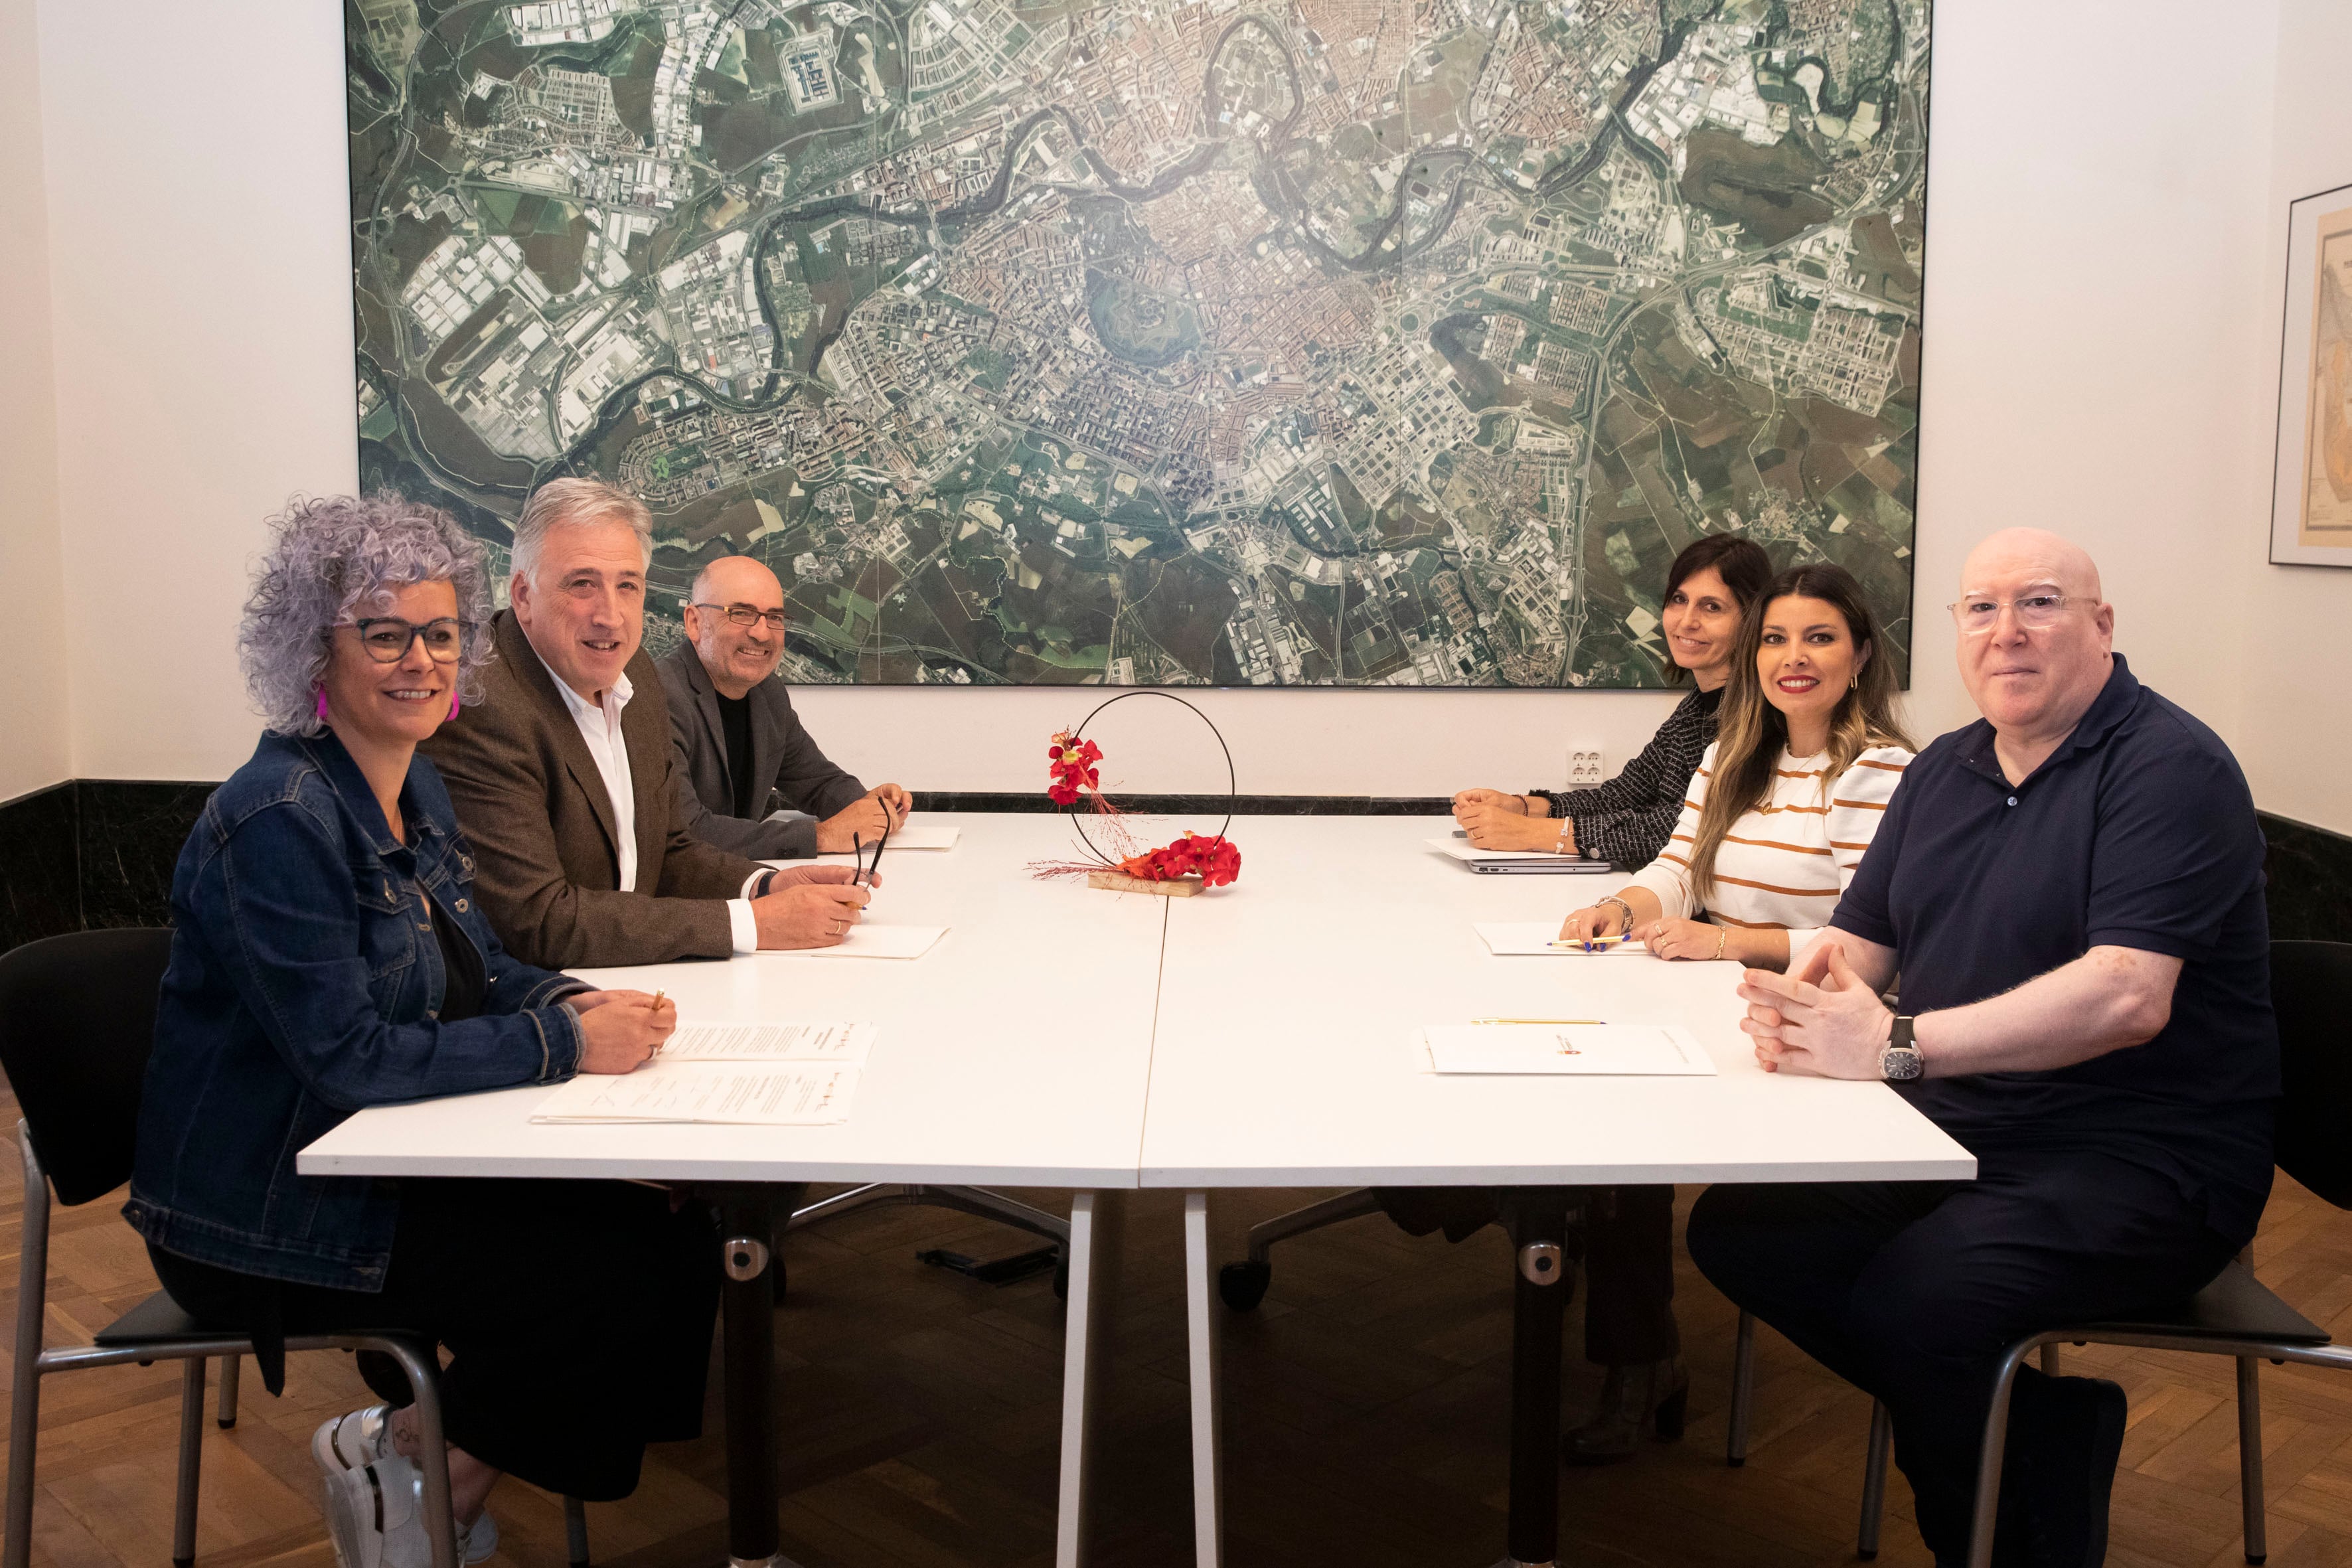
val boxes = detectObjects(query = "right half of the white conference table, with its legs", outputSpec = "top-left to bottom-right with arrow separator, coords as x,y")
1140,816 -> 1976,1568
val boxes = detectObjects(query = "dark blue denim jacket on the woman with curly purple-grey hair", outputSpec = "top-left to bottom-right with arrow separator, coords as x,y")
122,734 -> 588,1291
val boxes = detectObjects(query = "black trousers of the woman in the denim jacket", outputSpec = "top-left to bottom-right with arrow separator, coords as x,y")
148,1180 -> 720,1502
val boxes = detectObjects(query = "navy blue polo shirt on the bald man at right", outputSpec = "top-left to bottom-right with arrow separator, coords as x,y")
1832,653 -> 2279,1241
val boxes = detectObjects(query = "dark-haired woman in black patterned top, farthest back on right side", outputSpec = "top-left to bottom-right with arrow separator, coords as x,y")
1454,534 -> 1771,865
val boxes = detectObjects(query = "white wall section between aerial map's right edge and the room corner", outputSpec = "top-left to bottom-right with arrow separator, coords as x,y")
1912,0 -> 2276,740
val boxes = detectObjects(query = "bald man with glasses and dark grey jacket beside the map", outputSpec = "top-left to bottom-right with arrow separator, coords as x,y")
656,555 -> 915,860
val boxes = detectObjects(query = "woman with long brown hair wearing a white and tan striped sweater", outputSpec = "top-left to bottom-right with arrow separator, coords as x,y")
1559,562 -> 1912,1464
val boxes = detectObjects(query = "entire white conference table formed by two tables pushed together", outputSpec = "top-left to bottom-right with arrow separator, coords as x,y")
299,813 -> 1976,1568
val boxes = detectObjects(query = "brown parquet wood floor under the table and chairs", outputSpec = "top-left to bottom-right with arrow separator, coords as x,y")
0,1081 -> 2352,1568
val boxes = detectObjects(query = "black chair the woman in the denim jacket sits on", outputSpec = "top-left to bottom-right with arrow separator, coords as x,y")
0,931 -> 463,1568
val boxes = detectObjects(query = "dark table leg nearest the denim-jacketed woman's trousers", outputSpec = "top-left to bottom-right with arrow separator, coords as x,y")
718,1187 -> 800,1568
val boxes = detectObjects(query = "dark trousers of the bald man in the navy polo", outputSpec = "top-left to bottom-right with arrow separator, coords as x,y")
1689,1150 -> 2239,1565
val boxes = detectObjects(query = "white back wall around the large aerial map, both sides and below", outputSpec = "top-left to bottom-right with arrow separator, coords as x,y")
23,0 -> 2314,804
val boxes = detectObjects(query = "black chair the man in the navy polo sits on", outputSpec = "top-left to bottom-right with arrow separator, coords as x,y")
1724,943 -> 2352,1568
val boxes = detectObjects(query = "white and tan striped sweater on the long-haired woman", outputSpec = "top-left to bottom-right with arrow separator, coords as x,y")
1634,745 -> 1912,959
